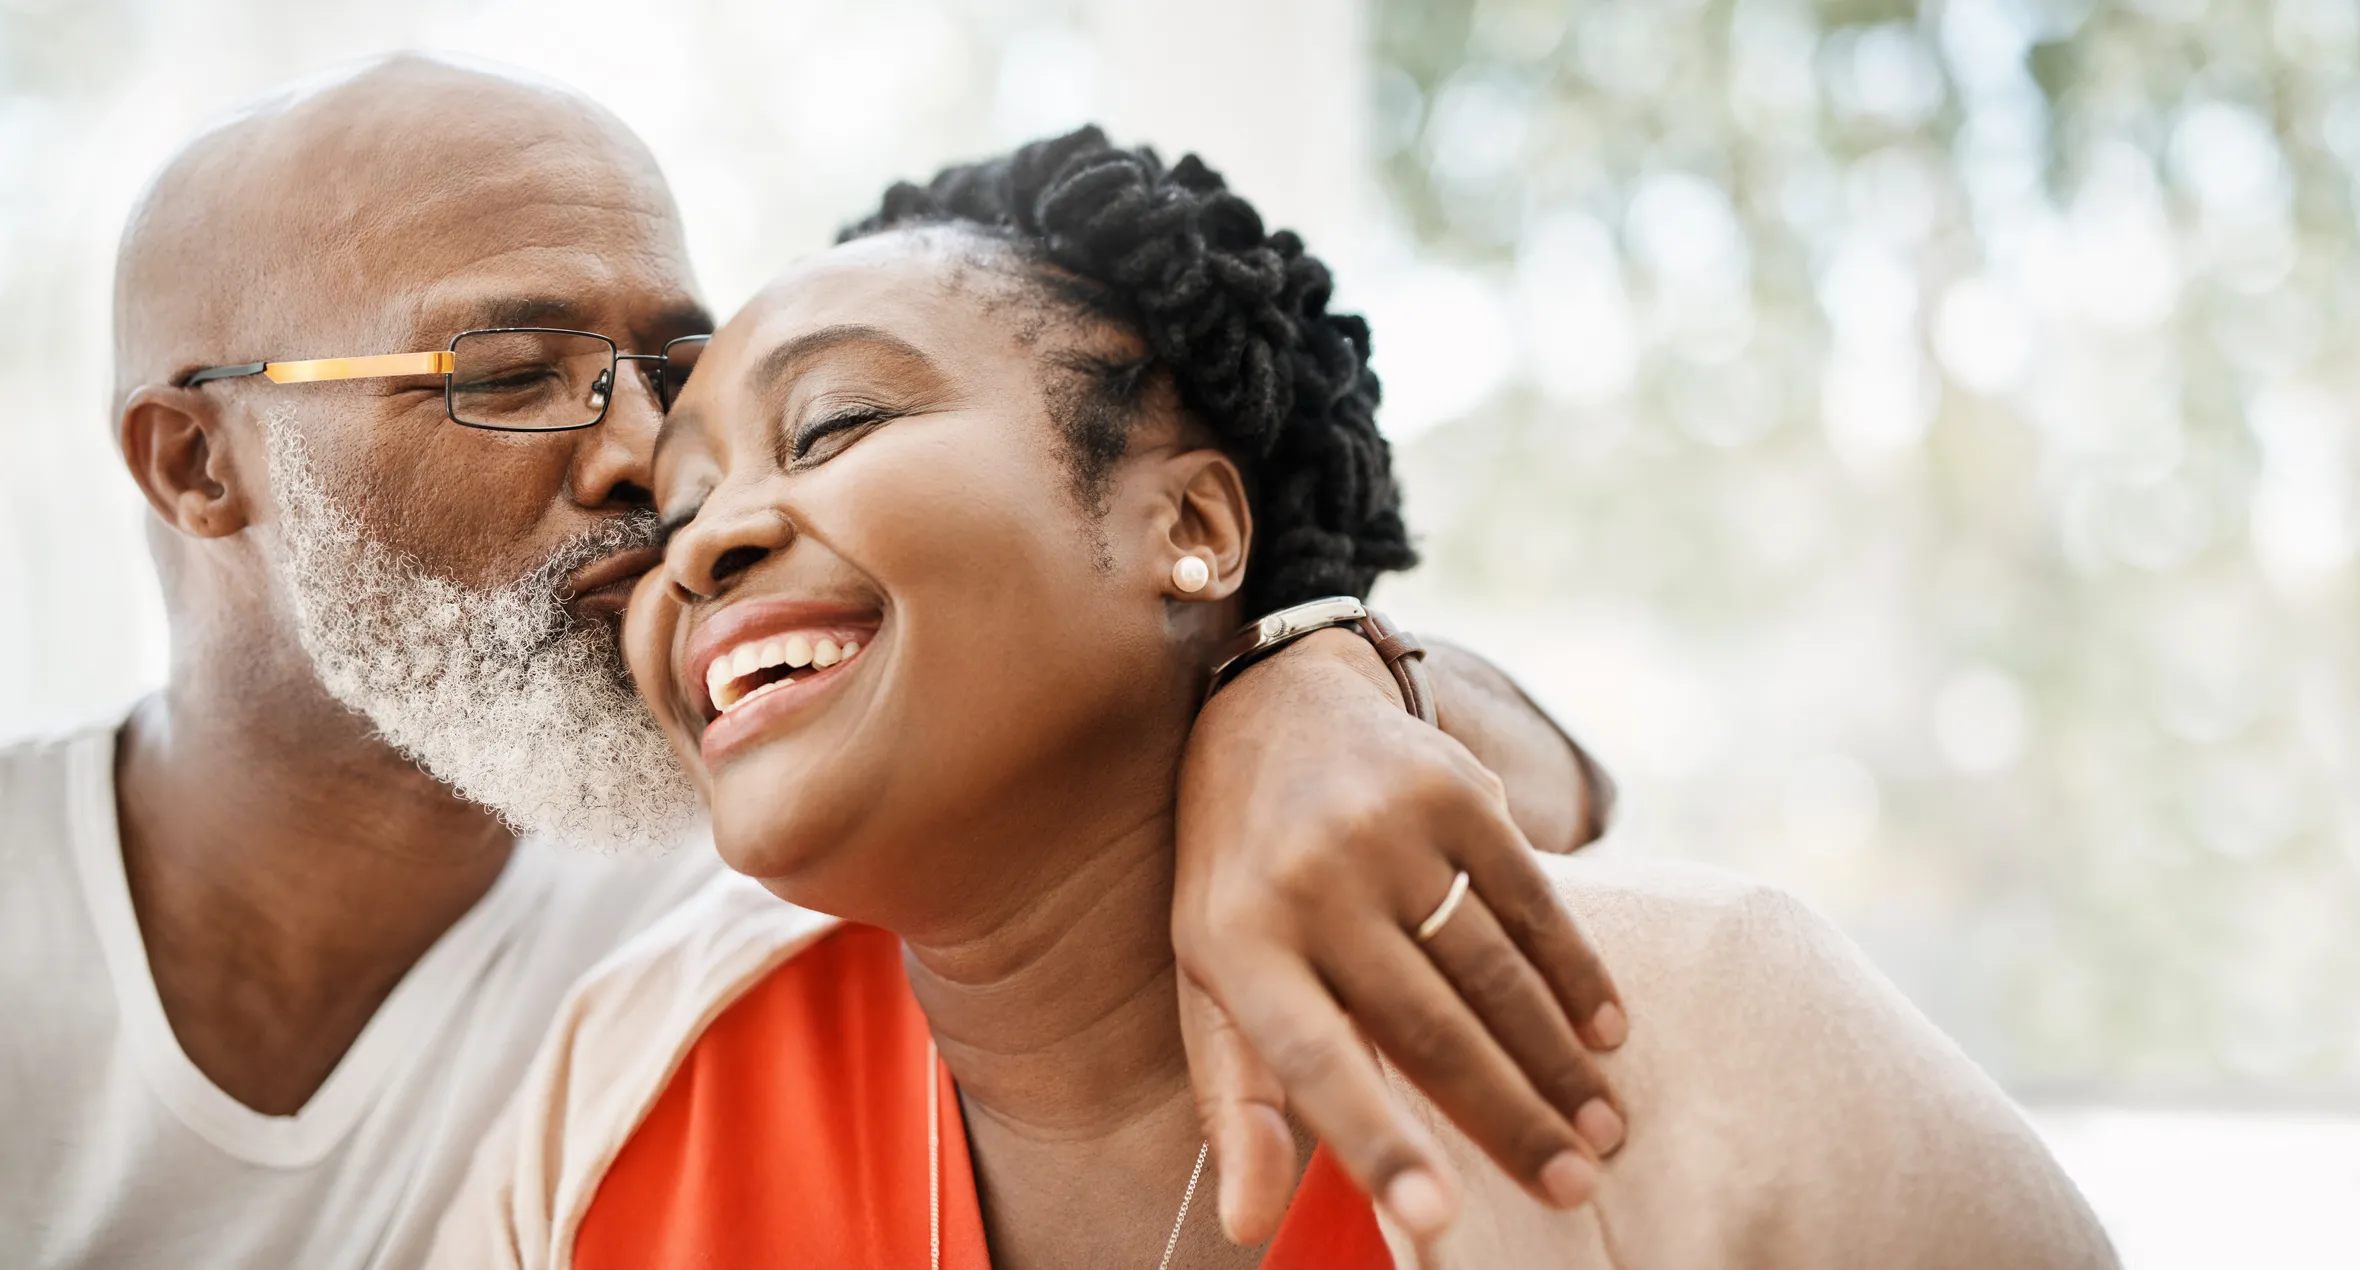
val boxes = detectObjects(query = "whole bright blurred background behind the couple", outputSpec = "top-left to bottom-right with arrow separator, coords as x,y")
0,0 -> 2360,1268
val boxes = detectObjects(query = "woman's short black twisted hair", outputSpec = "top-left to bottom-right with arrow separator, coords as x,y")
838,127 -> 1418,614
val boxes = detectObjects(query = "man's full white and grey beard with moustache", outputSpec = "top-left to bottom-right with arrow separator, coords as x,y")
264,415 -> 699,850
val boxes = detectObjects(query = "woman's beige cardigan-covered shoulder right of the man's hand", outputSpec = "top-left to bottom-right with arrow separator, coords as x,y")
1543,855 -> 2112,1268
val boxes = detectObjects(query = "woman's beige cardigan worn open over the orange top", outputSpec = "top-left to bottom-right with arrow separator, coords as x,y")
432,857 -> 2115,1270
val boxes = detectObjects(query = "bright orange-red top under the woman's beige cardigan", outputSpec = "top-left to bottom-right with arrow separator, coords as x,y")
573,925 -> 1392,1270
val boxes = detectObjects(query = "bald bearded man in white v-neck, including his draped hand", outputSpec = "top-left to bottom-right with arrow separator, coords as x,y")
0,57 -> 1621,1268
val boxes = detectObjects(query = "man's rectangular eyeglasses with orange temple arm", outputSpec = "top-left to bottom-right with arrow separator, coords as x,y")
175,326 -> 713,432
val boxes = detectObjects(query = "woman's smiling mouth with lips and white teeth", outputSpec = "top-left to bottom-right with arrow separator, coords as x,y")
680,597 -> 883,767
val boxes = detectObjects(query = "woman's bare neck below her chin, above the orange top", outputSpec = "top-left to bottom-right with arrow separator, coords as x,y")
909,805 -> 1256,1270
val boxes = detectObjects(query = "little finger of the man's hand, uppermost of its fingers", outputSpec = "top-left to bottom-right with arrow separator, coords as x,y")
1435,817 -> 1631,1050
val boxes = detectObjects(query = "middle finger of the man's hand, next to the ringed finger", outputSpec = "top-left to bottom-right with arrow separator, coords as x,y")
1331,920 -> 1598,1209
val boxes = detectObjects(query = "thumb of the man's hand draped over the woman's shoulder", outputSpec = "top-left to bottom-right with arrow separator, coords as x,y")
1180,975 -> 1298,1246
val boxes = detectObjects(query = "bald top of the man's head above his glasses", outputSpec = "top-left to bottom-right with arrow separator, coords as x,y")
116,54 -> 680,401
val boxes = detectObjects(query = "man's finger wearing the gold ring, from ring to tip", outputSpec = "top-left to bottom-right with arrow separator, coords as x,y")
1425,895 -> 1624,1157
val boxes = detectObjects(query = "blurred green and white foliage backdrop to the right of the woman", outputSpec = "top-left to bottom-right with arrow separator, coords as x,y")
1374,0 -> 2360,1098
